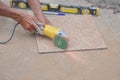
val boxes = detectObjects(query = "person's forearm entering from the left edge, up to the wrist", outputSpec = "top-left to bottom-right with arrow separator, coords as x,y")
0,1 -> 22,21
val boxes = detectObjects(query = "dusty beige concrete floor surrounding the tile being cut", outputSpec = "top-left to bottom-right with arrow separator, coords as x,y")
0,0 -> 120,80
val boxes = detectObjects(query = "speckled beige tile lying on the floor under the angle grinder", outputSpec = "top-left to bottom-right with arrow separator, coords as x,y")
36,15 -> 106,53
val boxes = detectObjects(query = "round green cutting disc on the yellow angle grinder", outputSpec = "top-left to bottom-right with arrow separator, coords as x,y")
54,36 -> 67,49
